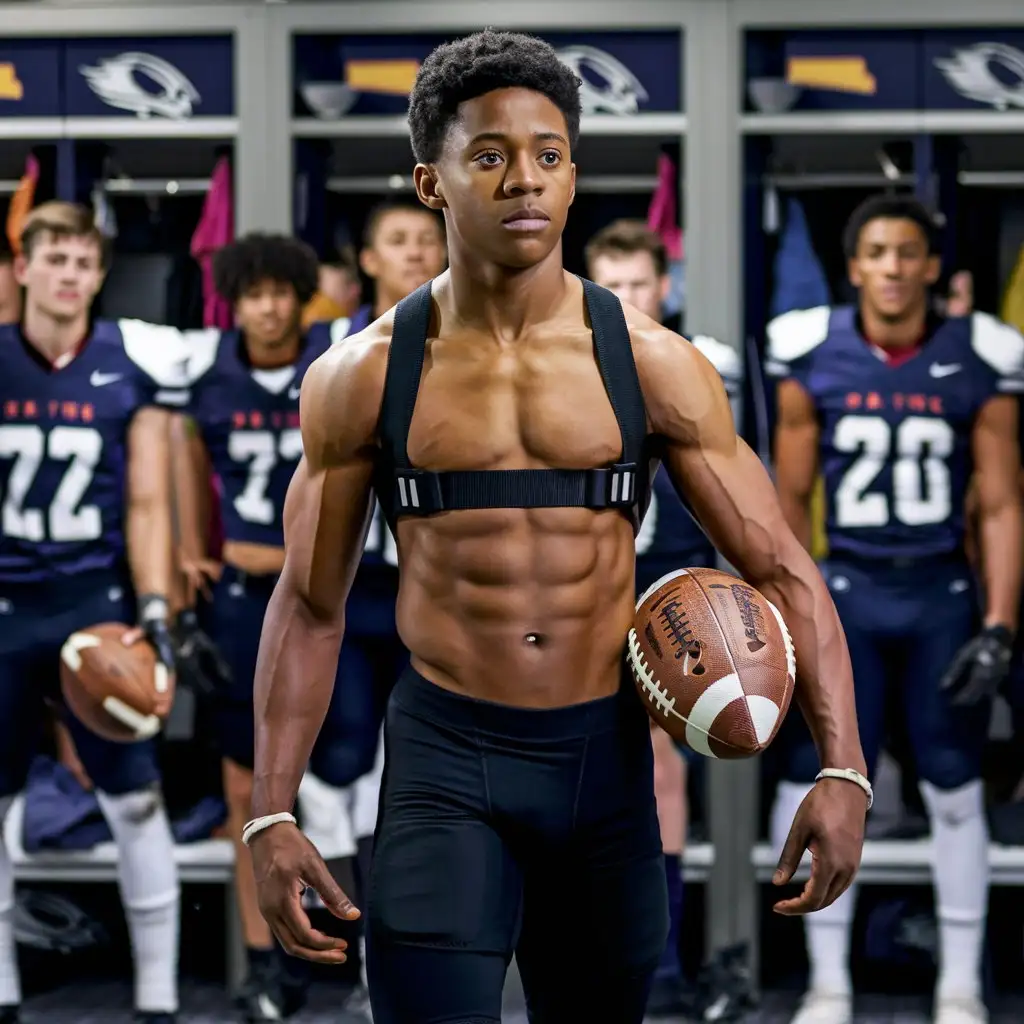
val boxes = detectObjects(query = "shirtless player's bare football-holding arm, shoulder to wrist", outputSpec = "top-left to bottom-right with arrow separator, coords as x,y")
634,328 -> 865,773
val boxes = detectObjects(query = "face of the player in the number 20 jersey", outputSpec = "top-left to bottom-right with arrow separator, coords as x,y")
849,217 -> 939,323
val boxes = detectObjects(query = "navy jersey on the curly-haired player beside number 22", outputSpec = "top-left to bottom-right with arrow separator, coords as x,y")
184,321 -> 345,547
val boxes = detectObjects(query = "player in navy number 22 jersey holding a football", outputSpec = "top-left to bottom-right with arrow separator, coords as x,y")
0,203 -> 184,1024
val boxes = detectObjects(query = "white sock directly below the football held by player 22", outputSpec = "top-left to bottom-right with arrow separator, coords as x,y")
96,786 -> 180,1013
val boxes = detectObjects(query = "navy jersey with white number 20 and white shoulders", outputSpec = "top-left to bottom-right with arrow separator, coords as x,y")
768,306 -> 1024,558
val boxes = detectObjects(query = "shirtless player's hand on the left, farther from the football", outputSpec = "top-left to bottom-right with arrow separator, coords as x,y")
249,821 -> 359,964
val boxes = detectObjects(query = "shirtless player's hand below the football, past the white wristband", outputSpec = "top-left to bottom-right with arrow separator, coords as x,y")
772,778 -> 867,916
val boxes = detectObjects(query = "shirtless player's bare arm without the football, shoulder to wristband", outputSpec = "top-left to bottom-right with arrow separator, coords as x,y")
252,338 -> 387,817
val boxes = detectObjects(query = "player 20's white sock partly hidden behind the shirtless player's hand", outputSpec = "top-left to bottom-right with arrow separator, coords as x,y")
770,782 -> 856,995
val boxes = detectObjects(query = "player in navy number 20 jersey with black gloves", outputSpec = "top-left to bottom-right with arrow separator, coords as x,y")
768,197 -> 1024,1024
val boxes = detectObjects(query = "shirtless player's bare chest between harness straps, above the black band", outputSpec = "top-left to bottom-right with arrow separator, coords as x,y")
409,332 -> 622,470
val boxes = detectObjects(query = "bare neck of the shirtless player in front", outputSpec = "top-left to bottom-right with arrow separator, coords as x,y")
441,243 -> 566,340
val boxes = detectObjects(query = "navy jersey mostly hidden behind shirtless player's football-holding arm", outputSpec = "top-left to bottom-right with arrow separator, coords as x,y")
636,336 -> 742,579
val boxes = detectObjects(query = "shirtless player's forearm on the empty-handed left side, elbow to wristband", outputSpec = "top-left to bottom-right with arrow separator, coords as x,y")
252,571 -> 344,817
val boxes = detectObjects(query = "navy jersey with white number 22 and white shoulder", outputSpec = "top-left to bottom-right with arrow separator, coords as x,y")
0,321 -> 186,591
